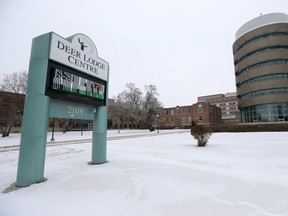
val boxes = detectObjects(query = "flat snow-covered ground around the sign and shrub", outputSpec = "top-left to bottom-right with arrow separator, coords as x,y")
0,130 -> 288,216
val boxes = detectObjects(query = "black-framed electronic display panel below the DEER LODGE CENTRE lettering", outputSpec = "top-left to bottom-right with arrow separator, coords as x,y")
45,61 -> 106,106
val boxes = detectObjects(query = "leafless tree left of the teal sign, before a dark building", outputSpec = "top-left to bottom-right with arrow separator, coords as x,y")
0,71 -> 27,137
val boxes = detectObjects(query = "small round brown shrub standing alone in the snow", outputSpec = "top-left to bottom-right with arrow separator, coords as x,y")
191,122 -> 213,147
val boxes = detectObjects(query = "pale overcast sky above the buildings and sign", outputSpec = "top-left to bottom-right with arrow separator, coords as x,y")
0,0 -> 288,107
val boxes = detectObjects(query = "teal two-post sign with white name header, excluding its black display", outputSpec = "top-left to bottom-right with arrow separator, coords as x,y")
16,32 -> 109,187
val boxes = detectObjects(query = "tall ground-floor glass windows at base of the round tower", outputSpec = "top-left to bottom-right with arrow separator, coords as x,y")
242,103 -> 288,123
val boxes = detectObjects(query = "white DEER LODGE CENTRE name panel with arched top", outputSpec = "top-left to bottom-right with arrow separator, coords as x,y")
49,32 -> 108,81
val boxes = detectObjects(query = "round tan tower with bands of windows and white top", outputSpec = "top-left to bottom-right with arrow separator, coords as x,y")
233,13 -> 288,123
